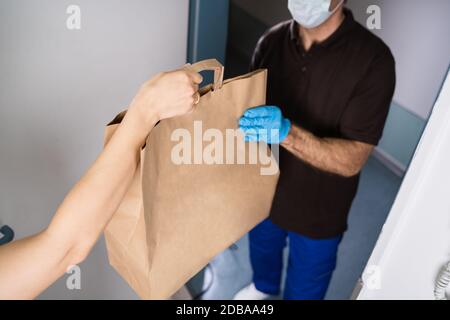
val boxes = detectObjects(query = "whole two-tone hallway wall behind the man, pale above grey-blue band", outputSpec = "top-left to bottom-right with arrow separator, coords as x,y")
348,0 -> 450,169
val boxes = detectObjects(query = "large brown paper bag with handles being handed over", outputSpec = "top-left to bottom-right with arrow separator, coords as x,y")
105,60 -> 278,299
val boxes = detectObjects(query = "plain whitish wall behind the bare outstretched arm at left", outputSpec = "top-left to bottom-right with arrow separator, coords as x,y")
0,0 -> 189,299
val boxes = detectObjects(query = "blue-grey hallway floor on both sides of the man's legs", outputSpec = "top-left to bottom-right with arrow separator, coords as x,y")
203,158 -> 401,299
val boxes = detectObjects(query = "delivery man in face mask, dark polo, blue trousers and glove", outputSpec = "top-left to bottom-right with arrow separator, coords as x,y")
235,0 -> 395,300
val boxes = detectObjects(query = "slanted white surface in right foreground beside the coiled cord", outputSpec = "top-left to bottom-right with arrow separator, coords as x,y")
358,68 -> 450,299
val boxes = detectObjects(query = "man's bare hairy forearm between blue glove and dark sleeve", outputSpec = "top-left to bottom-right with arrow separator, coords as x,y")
281,125 -> 373,177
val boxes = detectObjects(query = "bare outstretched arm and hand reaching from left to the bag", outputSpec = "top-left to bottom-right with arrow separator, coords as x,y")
0,70 -> 202,299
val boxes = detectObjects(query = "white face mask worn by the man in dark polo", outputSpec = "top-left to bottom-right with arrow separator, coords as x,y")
288,0 -> 344,29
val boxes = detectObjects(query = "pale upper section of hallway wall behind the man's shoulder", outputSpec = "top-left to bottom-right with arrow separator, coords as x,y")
348,0 -> 450,119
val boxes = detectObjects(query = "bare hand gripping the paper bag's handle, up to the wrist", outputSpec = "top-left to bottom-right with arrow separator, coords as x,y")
129,69 -> 203,130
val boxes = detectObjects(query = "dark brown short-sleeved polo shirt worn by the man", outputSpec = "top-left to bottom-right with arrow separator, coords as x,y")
251,10 -> 395,239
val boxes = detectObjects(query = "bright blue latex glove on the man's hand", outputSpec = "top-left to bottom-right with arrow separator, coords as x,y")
239,106 -> 291,144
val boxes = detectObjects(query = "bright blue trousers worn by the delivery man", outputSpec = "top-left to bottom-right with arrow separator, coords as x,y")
249,219 -> 342,300
